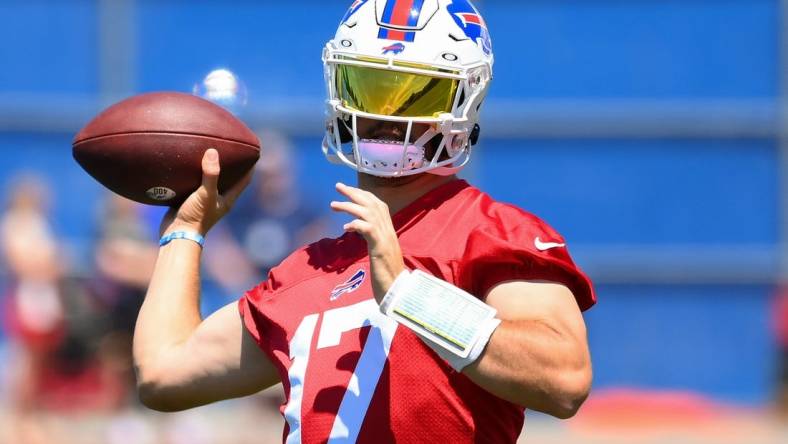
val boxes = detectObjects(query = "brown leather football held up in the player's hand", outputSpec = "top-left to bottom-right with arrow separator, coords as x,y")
73,92 -> 260,205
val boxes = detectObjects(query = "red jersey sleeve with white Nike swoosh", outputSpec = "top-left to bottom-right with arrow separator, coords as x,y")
458,209 -> 596,311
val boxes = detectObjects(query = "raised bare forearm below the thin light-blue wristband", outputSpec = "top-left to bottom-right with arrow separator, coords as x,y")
134,241 -> 201,394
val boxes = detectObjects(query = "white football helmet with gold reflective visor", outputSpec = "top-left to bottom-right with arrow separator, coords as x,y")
323,0 -> 493,177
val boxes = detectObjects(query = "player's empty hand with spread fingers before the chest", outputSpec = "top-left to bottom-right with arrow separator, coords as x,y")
331,183 -> 405,303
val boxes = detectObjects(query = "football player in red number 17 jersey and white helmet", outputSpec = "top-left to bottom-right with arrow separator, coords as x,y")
134,0 -> 595,443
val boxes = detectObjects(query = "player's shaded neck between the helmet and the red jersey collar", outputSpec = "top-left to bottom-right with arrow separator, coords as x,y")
358,173 -> 457,214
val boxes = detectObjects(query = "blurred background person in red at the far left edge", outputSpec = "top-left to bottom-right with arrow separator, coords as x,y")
0,175 -> 65,443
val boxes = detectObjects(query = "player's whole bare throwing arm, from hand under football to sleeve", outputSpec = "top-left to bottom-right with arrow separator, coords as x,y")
134,150 -> 279,411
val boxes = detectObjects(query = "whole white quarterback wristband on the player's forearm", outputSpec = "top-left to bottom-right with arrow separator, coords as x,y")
380,270 -> 501,371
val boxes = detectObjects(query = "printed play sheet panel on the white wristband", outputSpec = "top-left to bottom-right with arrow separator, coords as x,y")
391,273 -> 495,358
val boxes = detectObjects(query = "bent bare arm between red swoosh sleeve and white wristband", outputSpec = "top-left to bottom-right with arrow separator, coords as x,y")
469,281 -> 592,418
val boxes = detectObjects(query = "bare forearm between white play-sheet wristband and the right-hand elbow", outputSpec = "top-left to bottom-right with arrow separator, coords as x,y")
463,321 -> 591,418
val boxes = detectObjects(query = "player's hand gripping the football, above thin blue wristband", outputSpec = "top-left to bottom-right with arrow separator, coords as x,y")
161,148 -> 252,236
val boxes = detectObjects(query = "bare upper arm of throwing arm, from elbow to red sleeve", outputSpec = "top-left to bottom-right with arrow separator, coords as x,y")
141,303 -> 279,410
